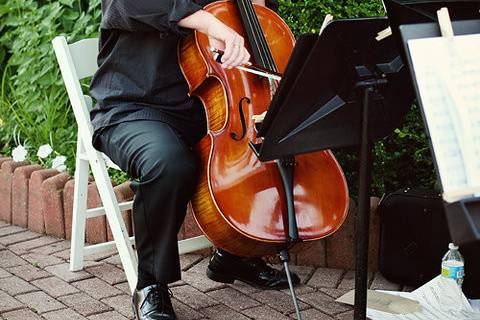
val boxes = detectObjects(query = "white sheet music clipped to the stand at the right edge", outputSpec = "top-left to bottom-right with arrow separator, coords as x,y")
408,34 -> 480,201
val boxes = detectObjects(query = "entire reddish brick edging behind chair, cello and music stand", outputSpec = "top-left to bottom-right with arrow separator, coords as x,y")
0,156 -> 380,271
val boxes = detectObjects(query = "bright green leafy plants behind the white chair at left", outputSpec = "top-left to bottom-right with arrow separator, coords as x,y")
0,0 -> 101,169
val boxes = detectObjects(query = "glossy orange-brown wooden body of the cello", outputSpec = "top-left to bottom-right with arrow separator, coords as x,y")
178,1 -> 348,256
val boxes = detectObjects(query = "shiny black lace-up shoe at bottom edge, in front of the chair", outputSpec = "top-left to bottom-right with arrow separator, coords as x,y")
132,284 -> 177,320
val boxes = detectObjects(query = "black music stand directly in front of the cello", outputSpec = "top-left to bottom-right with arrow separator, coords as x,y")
250,17 -> 413,320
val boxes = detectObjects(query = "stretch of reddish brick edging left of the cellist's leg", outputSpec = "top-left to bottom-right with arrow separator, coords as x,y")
0,156 -> 133,249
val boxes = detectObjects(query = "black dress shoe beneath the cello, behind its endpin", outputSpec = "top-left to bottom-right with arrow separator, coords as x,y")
207,249 -> 300,290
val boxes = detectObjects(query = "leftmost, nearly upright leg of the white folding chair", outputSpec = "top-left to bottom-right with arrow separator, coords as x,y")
70,139 -> 88,271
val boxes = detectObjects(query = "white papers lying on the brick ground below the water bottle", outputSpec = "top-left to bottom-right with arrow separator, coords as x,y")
367,276 -> 480,320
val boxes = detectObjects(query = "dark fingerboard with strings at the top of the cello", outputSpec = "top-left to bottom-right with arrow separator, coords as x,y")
235,0 -> 278,72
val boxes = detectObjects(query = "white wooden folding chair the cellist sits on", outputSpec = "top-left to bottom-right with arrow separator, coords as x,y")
52,36 -> 211,291
